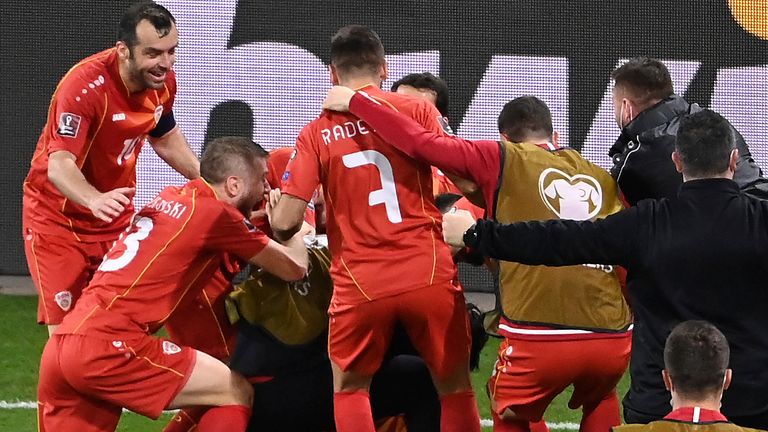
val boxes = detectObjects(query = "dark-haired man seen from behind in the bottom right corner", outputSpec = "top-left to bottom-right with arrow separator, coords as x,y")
612,321 -> 757,432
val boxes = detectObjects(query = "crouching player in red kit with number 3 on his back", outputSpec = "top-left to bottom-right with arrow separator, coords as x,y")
38,137 -> 308,432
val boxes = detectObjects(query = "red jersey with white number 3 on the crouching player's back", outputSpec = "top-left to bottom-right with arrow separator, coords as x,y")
58,179 -> 269,337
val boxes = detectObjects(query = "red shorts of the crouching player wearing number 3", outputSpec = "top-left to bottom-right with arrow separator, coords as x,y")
37,334 -> 196,432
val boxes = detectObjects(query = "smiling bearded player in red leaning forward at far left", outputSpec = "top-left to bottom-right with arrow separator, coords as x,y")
23,2 -> 200,332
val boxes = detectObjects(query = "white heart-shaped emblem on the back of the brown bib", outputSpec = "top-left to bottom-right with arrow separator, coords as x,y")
539,168 -> 603,220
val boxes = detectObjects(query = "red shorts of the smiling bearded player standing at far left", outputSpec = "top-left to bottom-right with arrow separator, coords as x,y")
24,229 -> 117,325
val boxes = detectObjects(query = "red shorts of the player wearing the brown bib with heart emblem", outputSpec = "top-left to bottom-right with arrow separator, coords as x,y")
488,333 -> 632,422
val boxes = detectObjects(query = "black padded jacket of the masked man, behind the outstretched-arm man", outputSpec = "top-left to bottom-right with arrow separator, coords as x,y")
608,95 -> 768,206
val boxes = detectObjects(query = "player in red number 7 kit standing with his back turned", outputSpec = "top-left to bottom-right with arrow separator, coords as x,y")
272,25 -> 480,432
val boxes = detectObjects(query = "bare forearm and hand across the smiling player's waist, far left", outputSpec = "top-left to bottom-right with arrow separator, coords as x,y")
48,150 -> 136,223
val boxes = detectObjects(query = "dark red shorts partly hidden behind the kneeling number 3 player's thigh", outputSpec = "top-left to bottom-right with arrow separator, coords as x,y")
165,273 -> 237,363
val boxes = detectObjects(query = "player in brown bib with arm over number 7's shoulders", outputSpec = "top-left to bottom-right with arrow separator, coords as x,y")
325,87 -> 632,432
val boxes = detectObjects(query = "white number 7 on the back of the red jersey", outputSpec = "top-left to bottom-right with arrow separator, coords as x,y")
341,150 -> 403,223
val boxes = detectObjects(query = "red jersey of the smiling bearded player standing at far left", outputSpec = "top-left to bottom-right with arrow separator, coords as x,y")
24,48 -> 176,241
